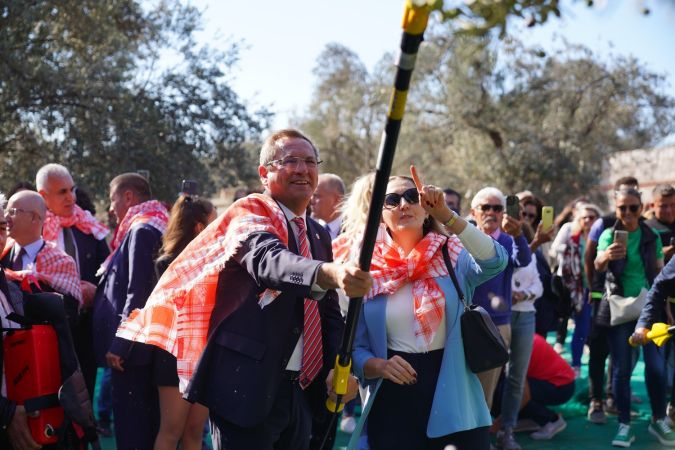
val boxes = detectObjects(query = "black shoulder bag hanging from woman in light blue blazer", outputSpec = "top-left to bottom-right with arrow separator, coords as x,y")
443,245 -> 509,373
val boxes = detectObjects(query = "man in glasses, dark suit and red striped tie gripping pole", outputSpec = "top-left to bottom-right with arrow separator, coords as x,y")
188,130 -> 372,450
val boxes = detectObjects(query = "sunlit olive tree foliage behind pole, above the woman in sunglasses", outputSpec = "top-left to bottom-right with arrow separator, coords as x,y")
298,22 -> 675,206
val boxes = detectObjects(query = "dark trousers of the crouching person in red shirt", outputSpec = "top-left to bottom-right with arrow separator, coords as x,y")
518,378 -> 574,426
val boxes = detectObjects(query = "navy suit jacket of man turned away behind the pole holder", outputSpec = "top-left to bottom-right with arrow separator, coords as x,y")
93,224 -> 162,367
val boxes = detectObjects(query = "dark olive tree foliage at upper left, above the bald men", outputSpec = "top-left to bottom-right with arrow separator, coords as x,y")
0,0 -> 270,200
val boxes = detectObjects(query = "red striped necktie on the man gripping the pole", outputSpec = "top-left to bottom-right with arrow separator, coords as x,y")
293,217 -> 323,389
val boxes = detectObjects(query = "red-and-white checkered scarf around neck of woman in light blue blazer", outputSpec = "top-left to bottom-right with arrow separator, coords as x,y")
366,232 -> 463,351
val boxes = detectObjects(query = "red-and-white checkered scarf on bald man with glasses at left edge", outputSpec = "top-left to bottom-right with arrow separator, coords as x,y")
3,239 -> 82,305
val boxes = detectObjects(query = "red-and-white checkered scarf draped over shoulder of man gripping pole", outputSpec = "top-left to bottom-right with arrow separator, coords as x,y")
117,194 -> 288,387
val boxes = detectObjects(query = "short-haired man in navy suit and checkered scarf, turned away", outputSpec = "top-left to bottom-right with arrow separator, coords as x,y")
93,173 -> 168,450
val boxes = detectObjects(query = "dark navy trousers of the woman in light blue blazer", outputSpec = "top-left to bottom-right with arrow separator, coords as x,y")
368,349 -> 490,450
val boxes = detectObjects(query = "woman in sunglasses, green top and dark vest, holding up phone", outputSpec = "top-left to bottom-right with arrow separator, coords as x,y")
595,188 -> 675,447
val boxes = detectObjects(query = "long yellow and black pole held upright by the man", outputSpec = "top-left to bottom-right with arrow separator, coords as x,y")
326,0 -> 442,442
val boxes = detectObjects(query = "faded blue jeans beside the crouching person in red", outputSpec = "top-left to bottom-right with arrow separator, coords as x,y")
502,311 -> 536,428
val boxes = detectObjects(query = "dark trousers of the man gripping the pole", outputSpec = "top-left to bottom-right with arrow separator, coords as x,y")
210,380 -> 312,450
